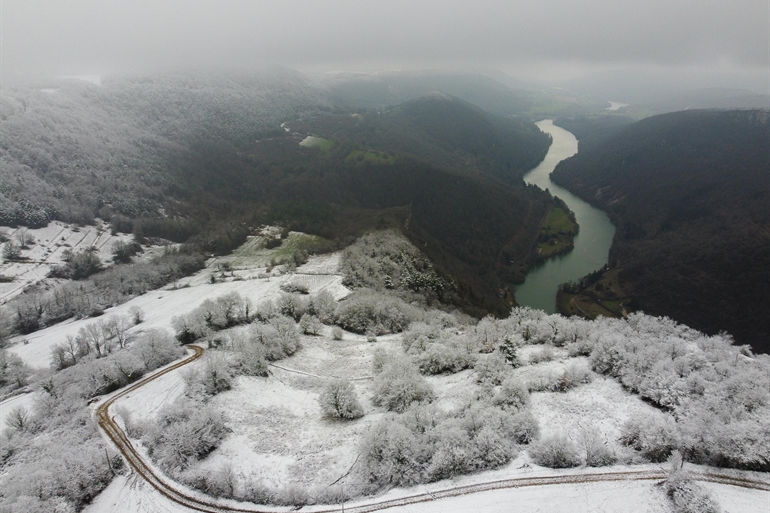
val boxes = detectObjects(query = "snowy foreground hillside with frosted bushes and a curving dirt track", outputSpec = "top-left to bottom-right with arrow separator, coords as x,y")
0,237 -> 770,513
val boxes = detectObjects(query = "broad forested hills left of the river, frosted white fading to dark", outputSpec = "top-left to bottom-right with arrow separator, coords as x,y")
0,69 -> 553,313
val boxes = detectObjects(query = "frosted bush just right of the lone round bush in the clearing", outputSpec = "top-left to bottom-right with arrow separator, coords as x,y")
372,358 -> 435,412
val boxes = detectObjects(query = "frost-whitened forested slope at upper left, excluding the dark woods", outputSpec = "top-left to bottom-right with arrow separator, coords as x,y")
0,69 -> 328,226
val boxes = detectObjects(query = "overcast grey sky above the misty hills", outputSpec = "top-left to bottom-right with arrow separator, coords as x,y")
0,0 -> 770,88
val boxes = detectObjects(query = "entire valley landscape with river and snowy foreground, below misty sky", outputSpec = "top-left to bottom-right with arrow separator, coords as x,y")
0,68 -> 770,513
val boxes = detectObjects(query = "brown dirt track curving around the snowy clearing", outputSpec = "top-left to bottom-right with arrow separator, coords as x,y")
96,346 -> 770,513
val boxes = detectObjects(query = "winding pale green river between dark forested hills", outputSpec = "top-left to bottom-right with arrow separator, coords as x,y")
516,119 -> 615,313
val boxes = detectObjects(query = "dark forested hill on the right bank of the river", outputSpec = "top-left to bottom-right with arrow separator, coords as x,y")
552,110 -> 770,352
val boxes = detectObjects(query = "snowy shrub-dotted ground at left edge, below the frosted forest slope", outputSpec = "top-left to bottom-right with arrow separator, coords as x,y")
0,221 -> 132,305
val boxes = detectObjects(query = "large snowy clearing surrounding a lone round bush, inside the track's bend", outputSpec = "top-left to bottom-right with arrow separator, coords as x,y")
202,333 -> 394,488
